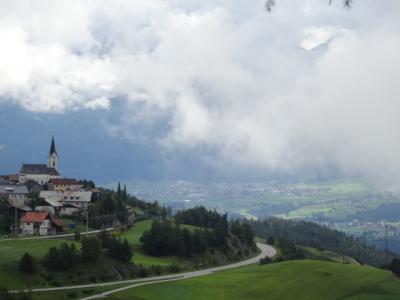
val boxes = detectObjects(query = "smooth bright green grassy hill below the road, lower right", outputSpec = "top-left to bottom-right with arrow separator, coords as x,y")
107,260 -> 400,300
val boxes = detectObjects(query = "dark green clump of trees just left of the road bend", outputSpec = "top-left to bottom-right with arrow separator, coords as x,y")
140,207 -> 254,257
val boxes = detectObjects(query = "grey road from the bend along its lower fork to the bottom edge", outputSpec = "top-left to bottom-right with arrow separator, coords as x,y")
77,243 -> 276,300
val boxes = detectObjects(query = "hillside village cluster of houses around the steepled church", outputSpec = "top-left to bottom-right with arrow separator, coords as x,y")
0,137 -> 99,236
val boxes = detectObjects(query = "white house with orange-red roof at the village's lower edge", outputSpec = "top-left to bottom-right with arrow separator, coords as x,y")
20,211 -> 51,235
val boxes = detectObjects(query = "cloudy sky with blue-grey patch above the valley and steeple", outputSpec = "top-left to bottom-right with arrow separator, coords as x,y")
0,0 -> 400,187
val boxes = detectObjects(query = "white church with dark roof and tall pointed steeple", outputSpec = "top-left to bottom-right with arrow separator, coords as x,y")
18,137 -> 60,185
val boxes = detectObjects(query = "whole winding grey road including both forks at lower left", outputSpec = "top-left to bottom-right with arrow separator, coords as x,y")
15,243 -> 276,300
